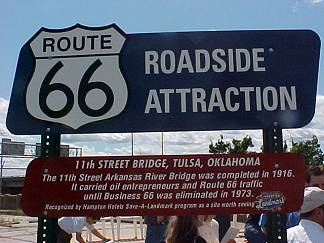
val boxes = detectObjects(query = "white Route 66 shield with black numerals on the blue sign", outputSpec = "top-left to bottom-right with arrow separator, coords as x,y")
25,25 -> 128,129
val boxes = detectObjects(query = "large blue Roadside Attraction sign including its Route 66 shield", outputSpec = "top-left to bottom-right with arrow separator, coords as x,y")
7,24 -> 320,134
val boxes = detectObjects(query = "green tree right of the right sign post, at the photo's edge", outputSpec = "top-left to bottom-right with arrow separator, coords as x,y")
290,135 -> 324,168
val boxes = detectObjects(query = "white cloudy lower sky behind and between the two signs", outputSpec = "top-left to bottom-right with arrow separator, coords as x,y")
0,95 -> 324,175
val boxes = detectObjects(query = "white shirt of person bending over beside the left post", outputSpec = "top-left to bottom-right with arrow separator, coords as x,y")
58,217 -> 94,234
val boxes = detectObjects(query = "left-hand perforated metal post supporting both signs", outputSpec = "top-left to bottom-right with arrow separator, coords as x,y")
37,133 -> 61,243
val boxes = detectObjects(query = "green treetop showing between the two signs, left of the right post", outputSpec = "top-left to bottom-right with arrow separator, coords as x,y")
209,135 -> 254,154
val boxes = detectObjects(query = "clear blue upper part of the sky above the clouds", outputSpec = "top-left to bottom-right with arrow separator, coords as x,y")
0,0 -> 324,99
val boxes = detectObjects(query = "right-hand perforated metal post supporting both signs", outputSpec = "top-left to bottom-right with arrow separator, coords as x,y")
263,124 -> 287,243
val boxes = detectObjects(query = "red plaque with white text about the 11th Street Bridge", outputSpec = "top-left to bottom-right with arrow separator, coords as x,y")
22,153 -> 305,217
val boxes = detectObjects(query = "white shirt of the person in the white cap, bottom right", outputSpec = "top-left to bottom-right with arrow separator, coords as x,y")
287,219 -> 324,243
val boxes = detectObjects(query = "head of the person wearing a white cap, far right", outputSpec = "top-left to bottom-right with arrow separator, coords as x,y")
300,187 -> 324,227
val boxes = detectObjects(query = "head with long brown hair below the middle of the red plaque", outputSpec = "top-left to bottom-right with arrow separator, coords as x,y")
166,215 -> 198,243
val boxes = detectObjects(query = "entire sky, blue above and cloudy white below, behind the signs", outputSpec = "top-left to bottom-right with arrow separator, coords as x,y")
0,0 -> 324,176
